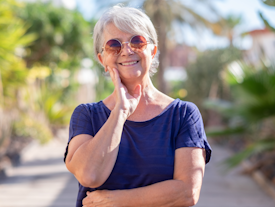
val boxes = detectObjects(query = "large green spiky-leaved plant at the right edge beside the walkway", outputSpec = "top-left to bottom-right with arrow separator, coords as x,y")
205,63 -> 275,166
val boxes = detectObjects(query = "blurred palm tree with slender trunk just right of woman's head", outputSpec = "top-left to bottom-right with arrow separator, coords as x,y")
143,0 -> 223,92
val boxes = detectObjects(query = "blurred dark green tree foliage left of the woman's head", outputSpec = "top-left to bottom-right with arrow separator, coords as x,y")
17,2 -> 92,70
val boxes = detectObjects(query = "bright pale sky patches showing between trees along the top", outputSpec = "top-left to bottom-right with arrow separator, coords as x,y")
74,0 -> 275,50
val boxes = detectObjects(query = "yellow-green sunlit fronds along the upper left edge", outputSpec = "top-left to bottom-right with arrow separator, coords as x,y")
0,0 -> 36,108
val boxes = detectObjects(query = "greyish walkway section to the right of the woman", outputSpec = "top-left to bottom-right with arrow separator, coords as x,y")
196,140 -> 275,207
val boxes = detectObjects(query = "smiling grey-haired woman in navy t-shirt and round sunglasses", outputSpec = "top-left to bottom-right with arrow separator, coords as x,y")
65,6 -> 211,207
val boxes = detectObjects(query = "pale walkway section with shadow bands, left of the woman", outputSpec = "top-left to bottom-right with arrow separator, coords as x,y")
0,133 -> 78,207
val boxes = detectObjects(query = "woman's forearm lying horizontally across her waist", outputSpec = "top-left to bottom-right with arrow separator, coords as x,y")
111,180 -> 200,207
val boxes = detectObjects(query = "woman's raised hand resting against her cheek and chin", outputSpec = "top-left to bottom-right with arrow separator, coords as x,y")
107,66 -> 141,120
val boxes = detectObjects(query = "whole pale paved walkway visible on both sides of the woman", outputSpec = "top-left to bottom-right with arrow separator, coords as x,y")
0,136 -> 275,207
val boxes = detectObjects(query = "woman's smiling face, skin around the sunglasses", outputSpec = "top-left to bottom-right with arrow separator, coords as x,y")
98,23 -> 157,81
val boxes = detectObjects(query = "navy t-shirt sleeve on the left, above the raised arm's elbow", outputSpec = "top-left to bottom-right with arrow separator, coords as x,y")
64,104 -> 94,162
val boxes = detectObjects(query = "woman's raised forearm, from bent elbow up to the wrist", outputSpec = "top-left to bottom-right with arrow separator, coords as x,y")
67,110 -> 126,188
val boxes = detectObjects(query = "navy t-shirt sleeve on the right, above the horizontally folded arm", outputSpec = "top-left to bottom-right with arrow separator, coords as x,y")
175,102 -> 212,163
